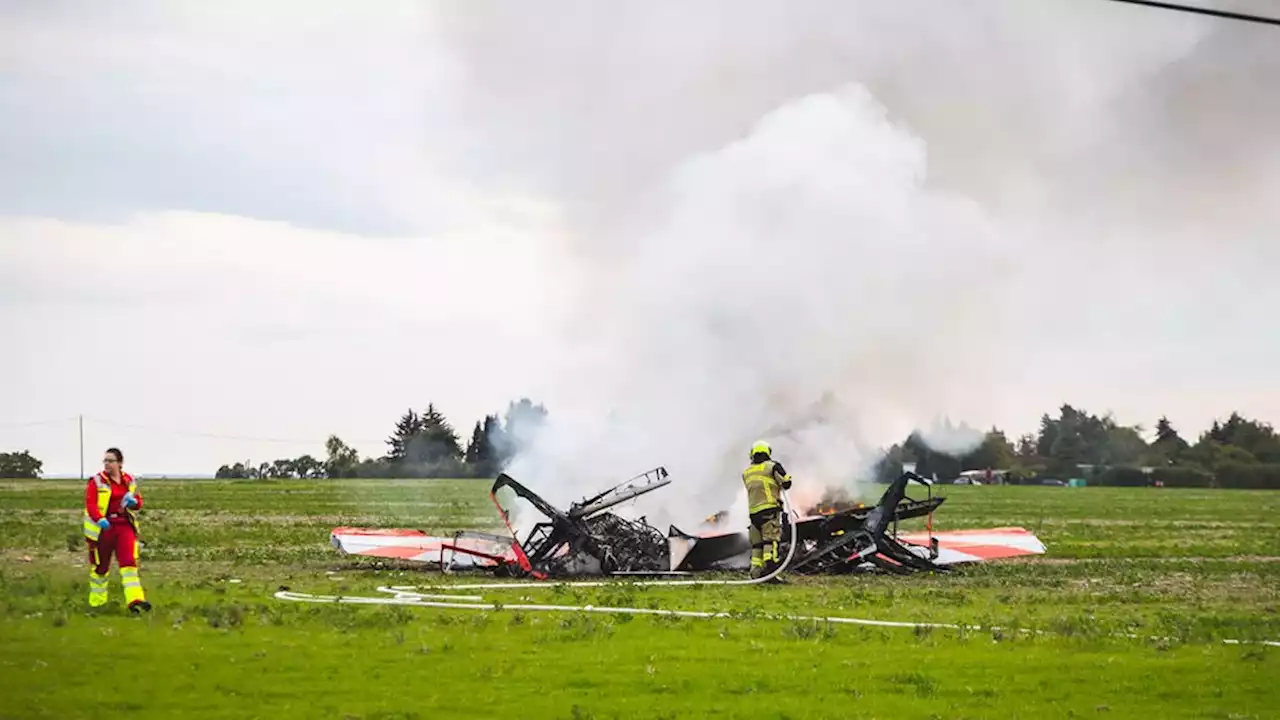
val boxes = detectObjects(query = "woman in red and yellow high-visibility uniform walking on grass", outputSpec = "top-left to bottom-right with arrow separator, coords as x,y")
83,447 -> 151,614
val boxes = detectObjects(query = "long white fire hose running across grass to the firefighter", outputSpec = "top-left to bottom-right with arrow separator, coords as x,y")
275,491 -> 1280,647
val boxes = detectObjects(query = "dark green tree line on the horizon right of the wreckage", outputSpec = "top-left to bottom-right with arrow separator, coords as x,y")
876,405 -> 1280,489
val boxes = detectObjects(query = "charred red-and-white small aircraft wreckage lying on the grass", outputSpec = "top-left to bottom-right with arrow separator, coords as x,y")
330,466 -> 1044,579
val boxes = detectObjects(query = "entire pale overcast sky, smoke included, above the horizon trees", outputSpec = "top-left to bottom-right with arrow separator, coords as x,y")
0,0 -> 1280,487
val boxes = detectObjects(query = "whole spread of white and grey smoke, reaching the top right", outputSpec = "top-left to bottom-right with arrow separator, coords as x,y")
432,0 -> 1280,524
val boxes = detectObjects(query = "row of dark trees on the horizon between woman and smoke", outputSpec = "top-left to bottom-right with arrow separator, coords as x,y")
215,397 -> 547,478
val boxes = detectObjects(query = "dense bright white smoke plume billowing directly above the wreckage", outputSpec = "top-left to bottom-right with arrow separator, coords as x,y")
499,86 -> 1004,520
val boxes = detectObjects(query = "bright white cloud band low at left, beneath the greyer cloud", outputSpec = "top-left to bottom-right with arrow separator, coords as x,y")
0,204 -> 570,471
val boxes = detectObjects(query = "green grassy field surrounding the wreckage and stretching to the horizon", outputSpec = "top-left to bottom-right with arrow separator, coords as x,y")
0,480 -> 1280,720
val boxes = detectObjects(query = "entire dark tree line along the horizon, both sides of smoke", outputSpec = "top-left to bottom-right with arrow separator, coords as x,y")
0,398 -> 1280,489
